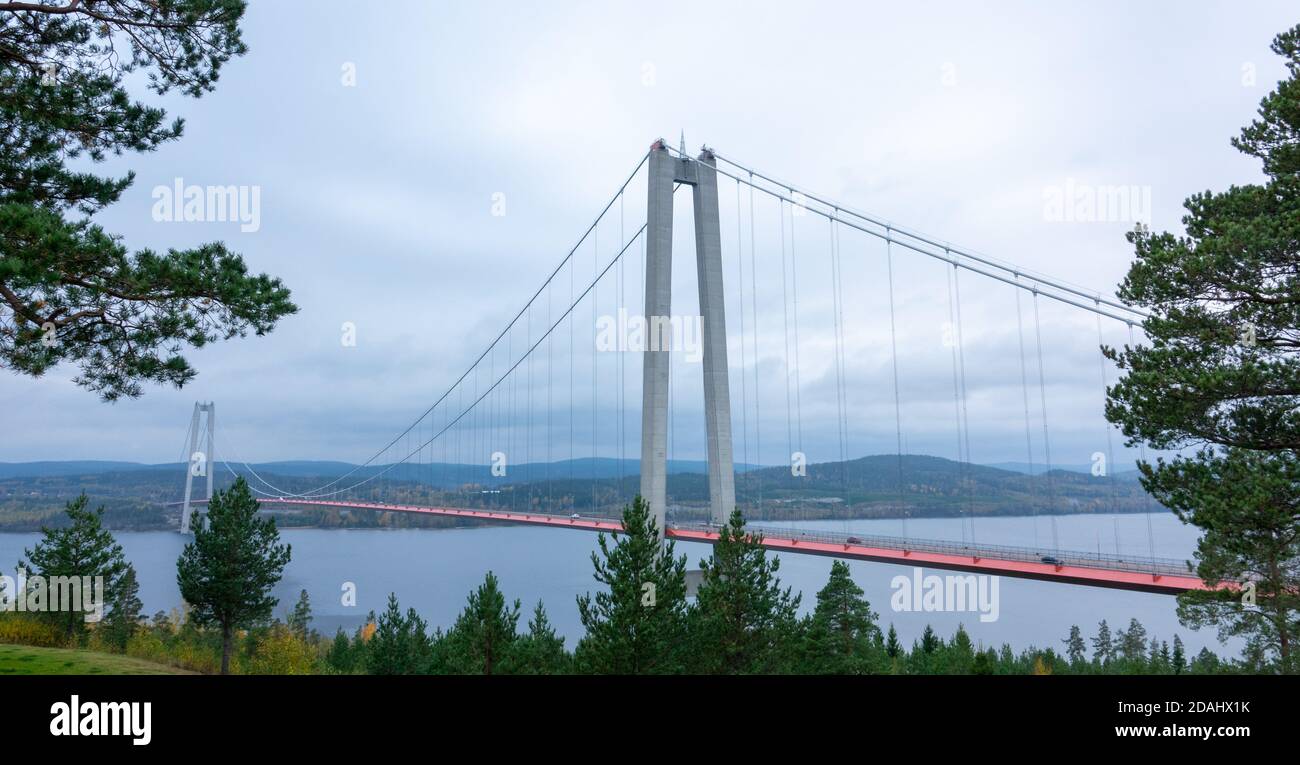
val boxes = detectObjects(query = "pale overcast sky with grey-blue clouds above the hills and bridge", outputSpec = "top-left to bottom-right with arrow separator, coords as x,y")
0,1 -> 1296,464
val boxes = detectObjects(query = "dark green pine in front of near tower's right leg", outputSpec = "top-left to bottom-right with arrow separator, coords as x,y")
688,510 -> 800,674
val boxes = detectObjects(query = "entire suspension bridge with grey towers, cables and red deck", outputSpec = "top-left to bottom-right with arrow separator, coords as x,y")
178,141 -> 1208,593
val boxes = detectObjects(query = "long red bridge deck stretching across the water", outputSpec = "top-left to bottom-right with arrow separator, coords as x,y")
195,497 -> 1206,595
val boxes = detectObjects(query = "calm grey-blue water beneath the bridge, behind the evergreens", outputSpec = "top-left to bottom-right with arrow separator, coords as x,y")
0,514 -> 1236,654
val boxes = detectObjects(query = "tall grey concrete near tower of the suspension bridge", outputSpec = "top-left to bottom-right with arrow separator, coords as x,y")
641,139 -> 736,536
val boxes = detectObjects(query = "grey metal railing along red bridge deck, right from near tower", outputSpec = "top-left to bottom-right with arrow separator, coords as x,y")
670,523 -> 1191,576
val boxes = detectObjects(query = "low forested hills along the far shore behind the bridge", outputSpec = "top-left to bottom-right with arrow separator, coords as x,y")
0,454 -> 1154,531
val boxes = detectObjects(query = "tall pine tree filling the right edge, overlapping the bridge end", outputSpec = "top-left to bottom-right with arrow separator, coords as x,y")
1105,26 -> 1300,673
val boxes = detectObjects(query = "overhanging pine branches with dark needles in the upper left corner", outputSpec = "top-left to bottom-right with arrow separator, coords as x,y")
0,0 -> 296,401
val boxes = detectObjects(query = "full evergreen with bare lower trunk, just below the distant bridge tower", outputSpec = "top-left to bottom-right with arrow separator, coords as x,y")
176,477 -> 291,674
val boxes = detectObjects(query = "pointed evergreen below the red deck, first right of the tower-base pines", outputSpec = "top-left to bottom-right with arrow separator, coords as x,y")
802,561 -> 883,674
